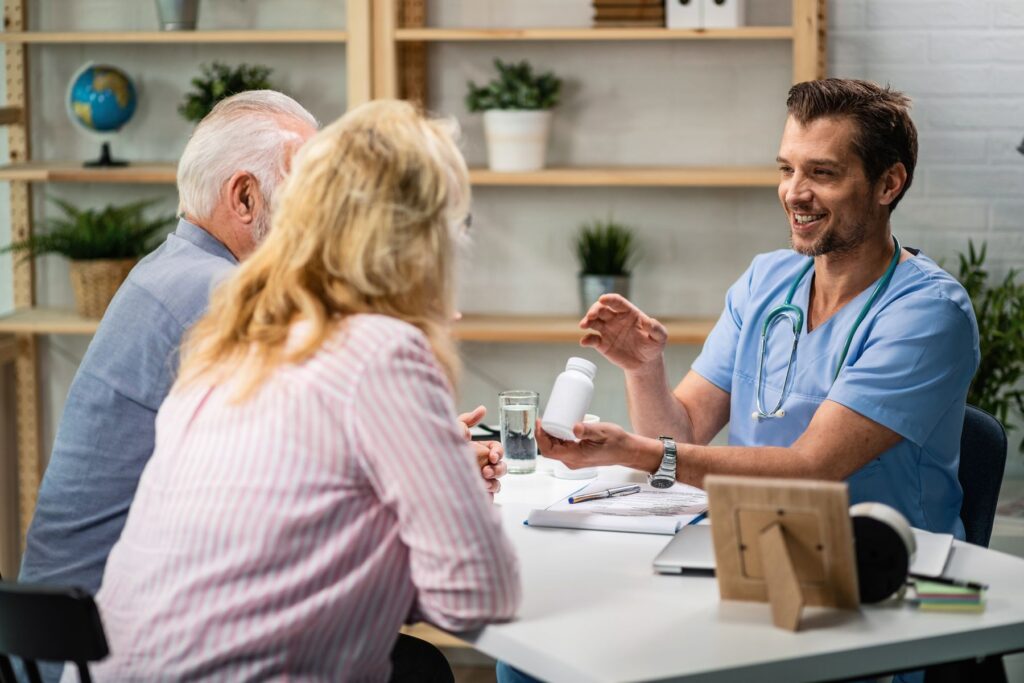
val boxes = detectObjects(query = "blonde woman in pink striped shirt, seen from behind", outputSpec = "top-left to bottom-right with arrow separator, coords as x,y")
75,101 -> 519,681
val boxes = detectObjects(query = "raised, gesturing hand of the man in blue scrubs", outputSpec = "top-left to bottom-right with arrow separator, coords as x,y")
581,294 -> 669,368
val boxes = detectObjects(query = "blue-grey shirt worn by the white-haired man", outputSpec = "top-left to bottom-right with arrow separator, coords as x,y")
18,220 -> 238,594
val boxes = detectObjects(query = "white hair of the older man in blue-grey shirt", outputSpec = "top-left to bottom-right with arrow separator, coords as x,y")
177,90 -> 318,220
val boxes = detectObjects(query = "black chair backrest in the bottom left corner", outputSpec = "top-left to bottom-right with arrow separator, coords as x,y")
0,582 -> 110,683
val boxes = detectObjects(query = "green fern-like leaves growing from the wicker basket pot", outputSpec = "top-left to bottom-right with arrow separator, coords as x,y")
0,198 -> 174,261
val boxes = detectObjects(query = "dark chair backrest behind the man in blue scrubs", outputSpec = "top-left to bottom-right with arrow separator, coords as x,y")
956,405 -> 1007,548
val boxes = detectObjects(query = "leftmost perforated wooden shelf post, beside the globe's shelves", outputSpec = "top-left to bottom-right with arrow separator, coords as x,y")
3,0 -> 42,544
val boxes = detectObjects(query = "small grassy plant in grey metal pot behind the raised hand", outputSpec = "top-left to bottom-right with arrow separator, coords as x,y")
575,218 -> 637,314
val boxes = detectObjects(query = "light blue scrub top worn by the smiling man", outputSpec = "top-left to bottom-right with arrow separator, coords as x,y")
692,250 -> 980,539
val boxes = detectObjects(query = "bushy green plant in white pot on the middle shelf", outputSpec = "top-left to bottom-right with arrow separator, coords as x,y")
466,59 -> 562,171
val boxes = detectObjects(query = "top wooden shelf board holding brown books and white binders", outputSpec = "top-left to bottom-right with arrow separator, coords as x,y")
395,26 -> 794,42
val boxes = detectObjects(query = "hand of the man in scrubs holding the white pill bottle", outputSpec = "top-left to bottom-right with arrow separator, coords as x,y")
537,421 -> 662,472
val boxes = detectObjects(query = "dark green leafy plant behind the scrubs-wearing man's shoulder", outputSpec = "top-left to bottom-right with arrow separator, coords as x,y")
957,241 -> 1024,449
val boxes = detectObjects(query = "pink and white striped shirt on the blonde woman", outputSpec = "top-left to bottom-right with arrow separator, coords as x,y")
79,315 -> 519,681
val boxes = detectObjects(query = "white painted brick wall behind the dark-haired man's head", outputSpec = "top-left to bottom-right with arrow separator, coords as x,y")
828,0 -> 1024,476
